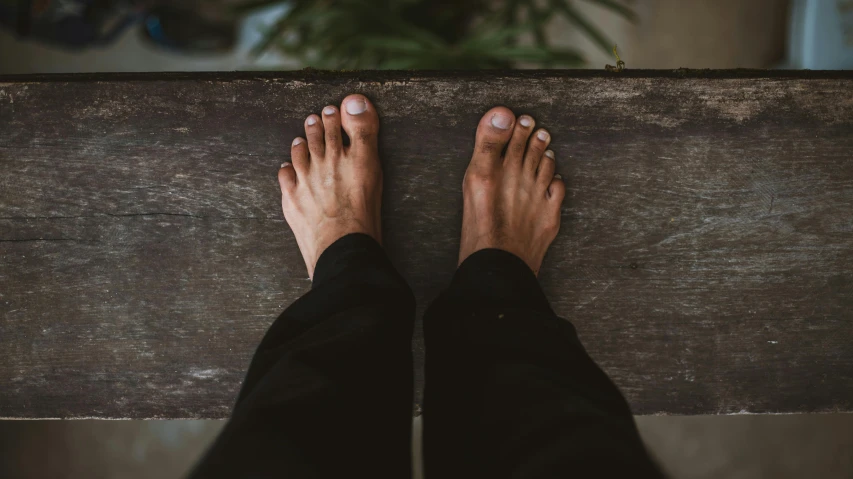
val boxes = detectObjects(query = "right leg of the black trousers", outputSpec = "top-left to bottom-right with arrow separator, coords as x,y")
423,249 -> 660,479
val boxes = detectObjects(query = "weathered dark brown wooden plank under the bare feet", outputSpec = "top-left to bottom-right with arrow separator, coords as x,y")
0,71 -> 853,418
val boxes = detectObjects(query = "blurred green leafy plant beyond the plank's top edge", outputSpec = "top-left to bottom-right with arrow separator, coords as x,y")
231,0 -> 636,69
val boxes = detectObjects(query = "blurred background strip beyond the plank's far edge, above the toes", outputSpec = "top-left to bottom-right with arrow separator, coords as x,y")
0,0 -> 853,74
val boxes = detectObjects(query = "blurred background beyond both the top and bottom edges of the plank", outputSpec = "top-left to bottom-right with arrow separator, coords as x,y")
0,0 -> 853,479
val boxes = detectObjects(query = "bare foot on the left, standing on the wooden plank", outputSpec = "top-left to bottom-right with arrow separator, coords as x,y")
278,95 -> 382,279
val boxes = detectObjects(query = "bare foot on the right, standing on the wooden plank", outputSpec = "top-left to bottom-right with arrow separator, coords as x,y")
459,107 -> 566,274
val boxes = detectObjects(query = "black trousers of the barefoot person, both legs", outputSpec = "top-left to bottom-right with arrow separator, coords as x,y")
191,234 -> 660,479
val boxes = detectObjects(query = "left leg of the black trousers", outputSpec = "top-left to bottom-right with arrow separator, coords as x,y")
191,234 -> 415,479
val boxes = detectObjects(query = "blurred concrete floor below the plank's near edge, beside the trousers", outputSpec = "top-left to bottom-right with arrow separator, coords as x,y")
0,414 -> 853,479
